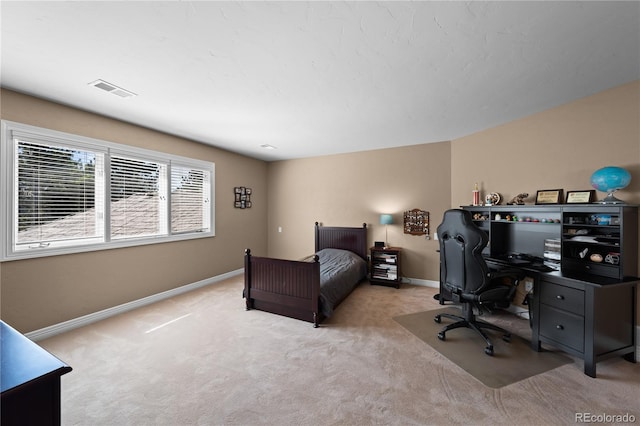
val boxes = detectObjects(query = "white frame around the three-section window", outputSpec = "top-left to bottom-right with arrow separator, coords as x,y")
0,120 -> 215,261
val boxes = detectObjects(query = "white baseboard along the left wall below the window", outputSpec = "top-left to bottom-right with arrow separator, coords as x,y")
25,269 -> 244,342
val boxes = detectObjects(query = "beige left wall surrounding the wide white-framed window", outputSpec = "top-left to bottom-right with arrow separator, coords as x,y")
0,90 -> 268,332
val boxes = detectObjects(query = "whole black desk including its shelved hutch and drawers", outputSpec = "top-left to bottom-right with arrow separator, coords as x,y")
458,204 -> 640,377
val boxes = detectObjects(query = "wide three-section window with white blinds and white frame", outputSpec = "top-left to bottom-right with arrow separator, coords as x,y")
0,121 -> 215,260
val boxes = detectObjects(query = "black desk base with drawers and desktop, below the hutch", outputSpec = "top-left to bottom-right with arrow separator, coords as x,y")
478,258 -> 638,377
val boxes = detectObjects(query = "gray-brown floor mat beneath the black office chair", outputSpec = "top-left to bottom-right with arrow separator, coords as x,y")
393,307 -> 573,389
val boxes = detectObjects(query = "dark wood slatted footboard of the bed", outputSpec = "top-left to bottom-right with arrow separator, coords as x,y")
244,249 -> 321,327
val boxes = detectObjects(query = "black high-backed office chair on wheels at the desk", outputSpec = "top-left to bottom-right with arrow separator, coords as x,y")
434,209 -> 524,355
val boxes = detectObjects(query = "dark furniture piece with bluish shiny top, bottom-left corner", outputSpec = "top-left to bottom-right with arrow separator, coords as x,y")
0,321 -> 71,426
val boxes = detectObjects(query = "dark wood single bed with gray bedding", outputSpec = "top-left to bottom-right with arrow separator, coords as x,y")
243,222 -> 367,327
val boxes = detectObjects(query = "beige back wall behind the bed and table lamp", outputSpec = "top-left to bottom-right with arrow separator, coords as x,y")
268,142 -> 451,280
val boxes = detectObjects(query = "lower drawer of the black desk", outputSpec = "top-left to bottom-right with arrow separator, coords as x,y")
540,305 -> 584,353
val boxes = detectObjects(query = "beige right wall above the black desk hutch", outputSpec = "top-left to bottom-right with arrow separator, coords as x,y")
451,81 -> 640,206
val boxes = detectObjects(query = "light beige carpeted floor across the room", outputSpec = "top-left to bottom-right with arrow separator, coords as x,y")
39,276 -> 640,426
